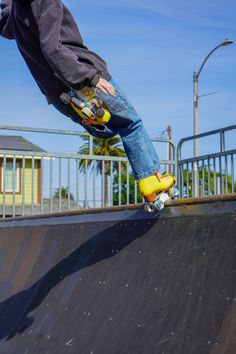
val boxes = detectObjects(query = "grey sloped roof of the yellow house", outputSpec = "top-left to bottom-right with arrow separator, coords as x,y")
0,135 -> 46,152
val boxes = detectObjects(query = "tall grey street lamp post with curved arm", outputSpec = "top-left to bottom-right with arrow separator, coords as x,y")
193,39 -> 233,197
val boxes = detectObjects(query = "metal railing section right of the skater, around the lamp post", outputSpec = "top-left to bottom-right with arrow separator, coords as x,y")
177,125 -> 236,198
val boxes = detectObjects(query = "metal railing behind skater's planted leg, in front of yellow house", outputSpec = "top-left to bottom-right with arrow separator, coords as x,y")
0,125 -> 177,218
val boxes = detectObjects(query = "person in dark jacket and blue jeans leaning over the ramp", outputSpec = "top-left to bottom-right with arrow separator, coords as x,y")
0,0 -> 174,206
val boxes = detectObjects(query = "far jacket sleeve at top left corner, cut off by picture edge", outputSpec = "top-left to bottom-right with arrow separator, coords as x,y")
0,0 -> 14,39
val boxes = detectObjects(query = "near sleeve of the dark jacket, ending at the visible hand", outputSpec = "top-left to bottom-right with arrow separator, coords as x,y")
36,0 -> 99,90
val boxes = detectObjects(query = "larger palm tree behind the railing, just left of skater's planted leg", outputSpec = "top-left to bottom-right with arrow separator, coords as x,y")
78,135 -> 126,206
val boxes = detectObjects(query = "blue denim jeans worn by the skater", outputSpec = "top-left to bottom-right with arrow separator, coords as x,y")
54,79 -> 160,180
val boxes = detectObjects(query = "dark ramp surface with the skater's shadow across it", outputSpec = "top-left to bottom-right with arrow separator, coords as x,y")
0,197 -> 236,354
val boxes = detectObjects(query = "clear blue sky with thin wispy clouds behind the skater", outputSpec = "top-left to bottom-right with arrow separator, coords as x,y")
0,0 -> 236,155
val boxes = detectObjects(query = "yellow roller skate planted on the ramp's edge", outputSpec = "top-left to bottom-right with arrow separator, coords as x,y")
138,174 -> 179,213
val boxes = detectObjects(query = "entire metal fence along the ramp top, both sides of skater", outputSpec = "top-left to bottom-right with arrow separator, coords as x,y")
0,125 -> 236,218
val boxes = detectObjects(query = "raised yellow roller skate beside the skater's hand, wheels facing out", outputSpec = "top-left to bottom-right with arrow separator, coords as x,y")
60,88 -> 111,125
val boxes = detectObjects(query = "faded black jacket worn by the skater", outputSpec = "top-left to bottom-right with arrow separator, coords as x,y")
0,0 -> 111,103
